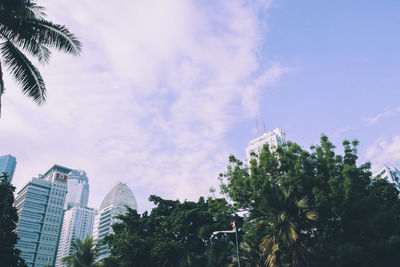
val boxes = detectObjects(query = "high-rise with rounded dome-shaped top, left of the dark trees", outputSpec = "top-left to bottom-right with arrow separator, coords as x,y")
93,182 -> 138,260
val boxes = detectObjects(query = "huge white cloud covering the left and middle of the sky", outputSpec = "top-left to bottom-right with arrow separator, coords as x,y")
0,0 -> 288,214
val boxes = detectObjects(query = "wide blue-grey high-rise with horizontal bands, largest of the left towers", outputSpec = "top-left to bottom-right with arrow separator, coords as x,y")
15,165 -> 71,267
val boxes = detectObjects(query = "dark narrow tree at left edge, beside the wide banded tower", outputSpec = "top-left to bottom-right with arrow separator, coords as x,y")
0,172 -> 26,267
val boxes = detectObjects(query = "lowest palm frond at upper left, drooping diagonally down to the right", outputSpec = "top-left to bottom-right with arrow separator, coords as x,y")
0,41 -> 46,104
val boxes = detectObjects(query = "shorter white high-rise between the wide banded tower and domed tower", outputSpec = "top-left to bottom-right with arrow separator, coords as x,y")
56,207 -> 97,267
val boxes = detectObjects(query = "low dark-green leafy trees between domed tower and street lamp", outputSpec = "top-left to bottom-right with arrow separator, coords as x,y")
106,196 -> 241,266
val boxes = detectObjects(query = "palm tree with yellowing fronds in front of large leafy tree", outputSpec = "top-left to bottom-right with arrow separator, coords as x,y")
257,186 -> 318,267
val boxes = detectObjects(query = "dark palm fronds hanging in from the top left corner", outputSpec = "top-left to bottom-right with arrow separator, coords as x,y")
0,0 -> 81,116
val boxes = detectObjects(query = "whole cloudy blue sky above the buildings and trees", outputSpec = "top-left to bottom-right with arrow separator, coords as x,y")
0,0 -> 400,212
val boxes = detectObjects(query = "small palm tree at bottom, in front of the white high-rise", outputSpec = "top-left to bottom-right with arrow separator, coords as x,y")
61,236 -> 97,267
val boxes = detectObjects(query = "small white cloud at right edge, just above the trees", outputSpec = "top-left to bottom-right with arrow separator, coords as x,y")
366,135 -> 400,170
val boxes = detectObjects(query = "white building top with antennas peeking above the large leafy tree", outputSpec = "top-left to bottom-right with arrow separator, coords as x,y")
246,128 -> 286,163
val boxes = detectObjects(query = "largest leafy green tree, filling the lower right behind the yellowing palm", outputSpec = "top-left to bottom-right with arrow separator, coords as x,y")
220,136 -> 400,266
